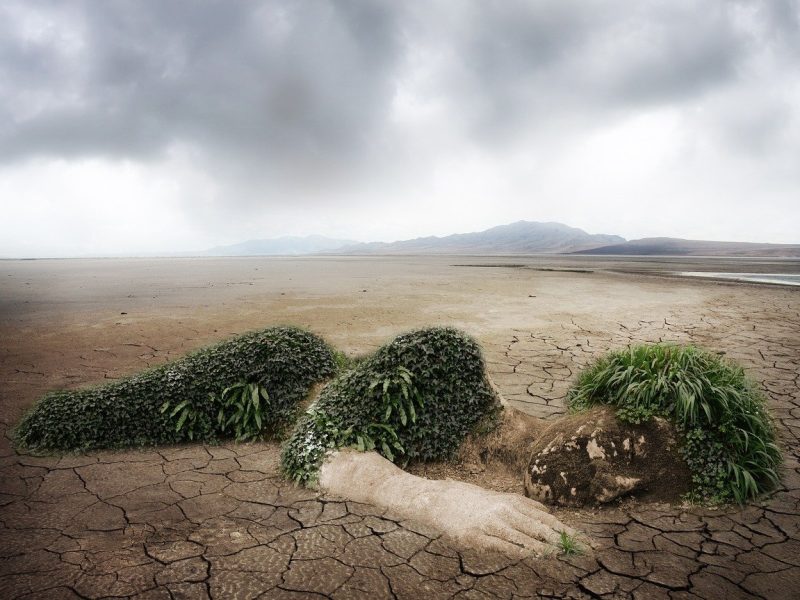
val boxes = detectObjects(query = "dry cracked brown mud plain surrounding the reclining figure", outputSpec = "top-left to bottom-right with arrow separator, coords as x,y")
0,259 -> 800,599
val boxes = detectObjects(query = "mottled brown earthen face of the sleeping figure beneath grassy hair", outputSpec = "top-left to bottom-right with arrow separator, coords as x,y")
525,407 -> 692,506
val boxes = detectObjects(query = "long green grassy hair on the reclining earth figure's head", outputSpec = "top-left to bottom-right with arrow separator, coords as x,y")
567,344 -> 781,504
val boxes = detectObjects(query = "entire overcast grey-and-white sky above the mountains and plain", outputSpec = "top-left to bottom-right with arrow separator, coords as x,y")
0,0 -> 800,256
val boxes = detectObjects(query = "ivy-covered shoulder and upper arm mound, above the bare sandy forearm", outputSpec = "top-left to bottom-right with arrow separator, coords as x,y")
282,327 -> 499,484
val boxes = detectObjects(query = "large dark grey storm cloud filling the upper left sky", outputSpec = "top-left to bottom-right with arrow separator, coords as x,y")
0,0 -> 398,171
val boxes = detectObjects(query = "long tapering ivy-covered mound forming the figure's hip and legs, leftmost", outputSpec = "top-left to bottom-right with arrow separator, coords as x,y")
16,327 -> 336,451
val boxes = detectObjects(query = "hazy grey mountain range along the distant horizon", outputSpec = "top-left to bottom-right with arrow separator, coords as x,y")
203,221 -> 800,257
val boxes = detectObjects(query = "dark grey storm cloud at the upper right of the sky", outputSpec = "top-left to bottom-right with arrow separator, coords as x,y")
410,0 -> 752,143
